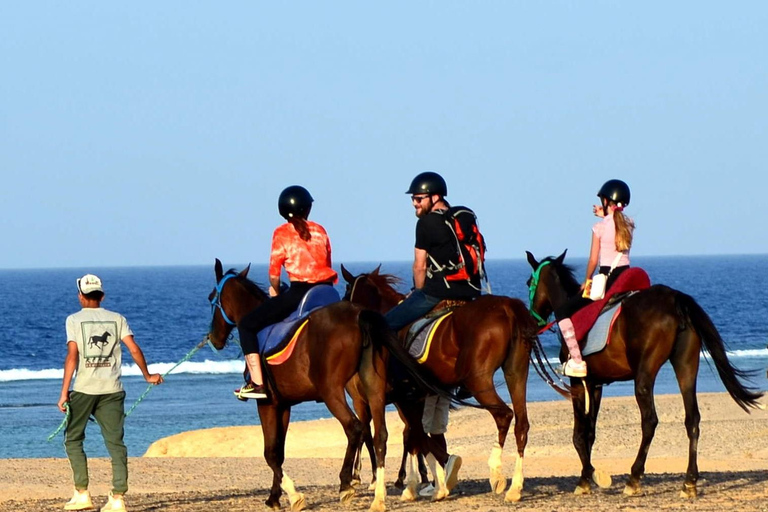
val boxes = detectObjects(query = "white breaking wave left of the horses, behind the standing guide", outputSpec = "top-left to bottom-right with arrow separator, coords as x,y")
0,359 -> 245,382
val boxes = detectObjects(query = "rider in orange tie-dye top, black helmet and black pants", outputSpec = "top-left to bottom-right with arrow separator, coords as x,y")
235,185 -> 338,400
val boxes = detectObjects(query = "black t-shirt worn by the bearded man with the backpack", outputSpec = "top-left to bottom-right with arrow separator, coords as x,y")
416,212 -> 480,299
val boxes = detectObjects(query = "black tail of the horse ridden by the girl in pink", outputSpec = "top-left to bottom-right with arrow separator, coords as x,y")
675,291 -> 763,412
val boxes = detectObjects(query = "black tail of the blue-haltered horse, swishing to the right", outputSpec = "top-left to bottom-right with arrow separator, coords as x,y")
359,309 -> 481,407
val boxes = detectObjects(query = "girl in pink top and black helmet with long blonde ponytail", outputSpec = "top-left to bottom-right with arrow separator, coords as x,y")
555,180 -> 635,377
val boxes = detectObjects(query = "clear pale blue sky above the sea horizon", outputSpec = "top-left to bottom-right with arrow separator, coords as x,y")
0,1 -> 768,268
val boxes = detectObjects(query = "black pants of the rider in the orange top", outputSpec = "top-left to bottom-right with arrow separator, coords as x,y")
237,281 -> 316,354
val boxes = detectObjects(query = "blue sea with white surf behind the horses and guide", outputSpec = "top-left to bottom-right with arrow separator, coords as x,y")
0,255 -> 768,458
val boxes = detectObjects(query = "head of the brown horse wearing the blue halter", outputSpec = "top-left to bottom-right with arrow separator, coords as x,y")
208,258 -> 267,350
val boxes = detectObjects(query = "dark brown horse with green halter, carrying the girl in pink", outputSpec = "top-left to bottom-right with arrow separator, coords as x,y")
526,252 -> 762,498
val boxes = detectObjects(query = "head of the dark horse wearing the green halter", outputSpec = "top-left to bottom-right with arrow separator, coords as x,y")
525,249 -> 579,326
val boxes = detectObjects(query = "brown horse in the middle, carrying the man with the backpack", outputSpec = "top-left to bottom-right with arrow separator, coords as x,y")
341,266 -> 560,502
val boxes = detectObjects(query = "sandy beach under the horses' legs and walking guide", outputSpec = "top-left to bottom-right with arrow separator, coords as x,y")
0,393 -> 768,512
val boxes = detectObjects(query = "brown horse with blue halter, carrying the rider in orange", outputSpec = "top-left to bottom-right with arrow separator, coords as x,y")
208,259 -> 396,511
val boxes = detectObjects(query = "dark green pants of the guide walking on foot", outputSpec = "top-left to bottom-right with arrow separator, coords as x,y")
64,391 -> 128,494
